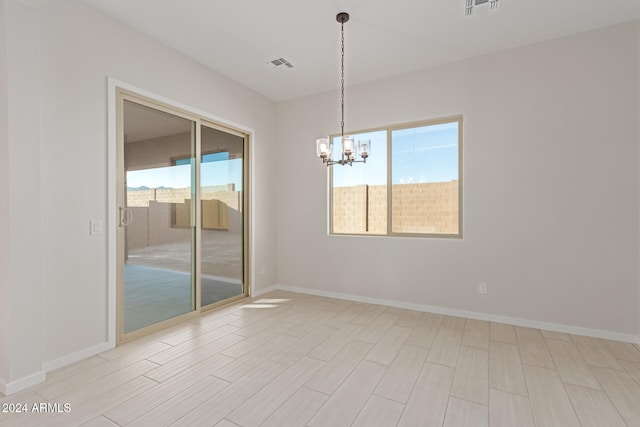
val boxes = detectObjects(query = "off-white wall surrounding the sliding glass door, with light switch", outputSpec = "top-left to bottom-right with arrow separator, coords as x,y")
0,0 -> 276,394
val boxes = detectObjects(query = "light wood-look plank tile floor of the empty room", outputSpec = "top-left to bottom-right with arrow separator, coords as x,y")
0,291 -> 640,427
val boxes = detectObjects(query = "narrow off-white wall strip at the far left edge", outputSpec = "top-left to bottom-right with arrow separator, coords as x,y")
0,1 -> 44,392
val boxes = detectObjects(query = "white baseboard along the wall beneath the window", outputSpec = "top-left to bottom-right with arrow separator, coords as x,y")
276,285 -> 640,344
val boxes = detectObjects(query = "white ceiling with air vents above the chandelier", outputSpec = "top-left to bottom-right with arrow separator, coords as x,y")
84,0 -> 640,101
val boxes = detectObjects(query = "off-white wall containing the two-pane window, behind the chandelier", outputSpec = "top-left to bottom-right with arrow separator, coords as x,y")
278,22 -> 639,337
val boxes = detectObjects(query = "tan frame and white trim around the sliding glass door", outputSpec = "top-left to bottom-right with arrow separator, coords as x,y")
107,79 -> 253,346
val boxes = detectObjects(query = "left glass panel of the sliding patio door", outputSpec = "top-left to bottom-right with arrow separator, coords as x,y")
120,100 -> 196,334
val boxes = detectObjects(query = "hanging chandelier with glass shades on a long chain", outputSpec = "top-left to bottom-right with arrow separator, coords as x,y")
316,12 -> 371,166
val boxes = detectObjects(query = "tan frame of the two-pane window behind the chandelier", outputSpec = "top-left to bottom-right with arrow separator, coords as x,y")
327,114 -> 463,239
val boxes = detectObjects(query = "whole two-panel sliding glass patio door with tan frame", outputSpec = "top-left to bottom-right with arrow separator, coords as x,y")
117,93 -> 248,341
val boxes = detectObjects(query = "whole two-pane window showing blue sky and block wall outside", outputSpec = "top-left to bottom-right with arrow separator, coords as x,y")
330,117 -> 462,237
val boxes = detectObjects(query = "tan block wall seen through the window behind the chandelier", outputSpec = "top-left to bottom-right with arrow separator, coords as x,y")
333,180 -> 458,234
